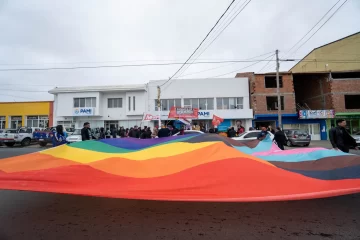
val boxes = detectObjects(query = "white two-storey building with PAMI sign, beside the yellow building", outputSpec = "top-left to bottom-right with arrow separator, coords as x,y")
49,84 -> 147,128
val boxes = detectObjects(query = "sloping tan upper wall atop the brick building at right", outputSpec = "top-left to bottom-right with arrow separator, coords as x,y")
290,33 -> 360,73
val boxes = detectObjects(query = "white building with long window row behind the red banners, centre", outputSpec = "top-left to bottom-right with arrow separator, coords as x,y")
145,78 -> 253,131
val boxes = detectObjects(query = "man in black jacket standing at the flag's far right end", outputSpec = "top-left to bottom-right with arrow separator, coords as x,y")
329,119 -> 359,153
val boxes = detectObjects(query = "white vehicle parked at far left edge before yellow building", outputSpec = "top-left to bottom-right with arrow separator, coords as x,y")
0,127 -> 35,147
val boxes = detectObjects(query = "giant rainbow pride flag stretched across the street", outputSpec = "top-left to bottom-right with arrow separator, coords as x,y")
0,134 -> 360,202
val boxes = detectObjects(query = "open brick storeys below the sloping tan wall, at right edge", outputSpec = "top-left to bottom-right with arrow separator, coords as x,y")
293,71 -> 360,134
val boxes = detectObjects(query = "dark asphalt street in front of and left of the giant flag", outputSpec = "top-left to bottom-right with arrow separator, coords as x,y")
0,147 -> 360,240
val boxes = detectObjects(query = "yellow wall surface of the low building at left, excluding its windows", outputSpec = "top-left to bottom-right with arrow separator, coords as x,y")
0,102 -> 52,128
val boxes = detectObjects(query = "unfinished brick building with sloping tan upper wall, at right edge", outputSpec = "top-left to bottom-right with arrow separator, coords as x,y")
290,32 -> 360,134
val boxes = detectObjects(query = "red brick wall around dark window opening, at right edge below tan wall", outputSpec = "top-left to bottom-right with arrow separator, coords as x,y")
330,79 -> 360,112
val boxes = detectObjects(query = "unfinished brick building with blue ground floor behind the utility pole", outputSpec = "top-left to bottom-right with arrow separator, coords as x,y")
236,72 -> 327,140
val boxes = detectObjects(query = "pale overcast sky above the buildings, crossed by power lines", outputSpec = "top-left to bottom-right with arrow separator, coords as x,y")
0,0 -> 360,101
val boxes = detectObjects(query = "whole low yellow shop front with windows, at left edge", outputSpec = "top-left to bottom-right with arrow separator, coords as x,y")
0,101 -> 53,129
